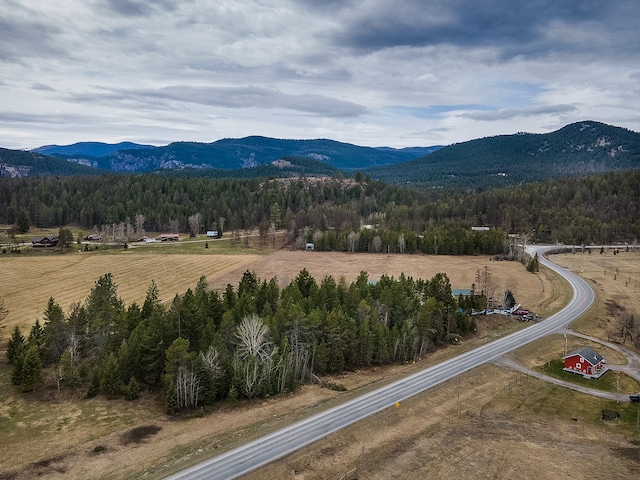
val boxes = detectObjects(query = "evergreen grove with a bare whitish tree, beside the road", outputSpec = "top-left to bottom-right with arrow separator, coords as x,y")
7,270 -> 486,413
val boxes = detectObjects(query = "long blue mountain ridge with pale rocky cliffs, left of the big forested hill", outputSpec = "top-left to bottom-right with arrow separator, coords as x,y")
51,136 -> 430,172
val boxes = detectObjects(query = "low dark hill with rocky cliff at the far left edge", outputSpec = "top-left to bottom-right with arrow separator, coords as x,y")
0,148 -> 100,178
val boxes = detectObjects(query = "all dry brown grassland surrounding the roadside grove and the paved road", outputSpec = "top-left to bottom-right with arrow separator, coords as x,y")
0,244 -> 640,480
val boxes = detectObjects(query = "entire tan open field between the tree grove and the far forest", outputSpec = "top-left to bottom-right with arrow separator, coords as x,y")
0,246 -> 563,332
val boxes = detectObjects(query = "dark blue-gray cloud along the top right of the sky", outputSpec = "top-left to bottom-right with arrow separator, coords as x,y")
334,0 -> 640,58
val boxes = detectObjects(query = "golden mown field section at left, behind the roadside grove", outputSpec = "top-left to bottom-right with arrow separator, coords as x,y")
0,252 -> 260,335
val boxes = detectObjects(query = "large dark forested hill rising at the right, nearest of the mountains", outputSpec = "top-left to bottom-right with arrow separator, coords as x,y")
367,121 -> 640,189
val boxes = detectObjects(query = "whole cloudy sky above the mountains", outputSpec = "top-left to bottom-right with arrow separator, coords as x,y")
0,0 -> 640,149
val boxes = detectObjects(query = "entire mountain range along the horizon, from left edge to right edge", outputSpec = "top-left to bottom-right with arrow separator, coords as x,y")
0,121 -> 640,190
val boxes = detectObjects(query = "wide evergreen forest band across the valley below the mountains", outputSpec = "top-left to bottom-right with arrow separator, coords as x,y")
0,170 -> 640,246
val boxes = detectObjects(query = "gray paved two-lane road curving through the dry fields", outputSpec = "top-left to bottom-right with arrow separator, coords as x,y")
169,247 -> 595,480
